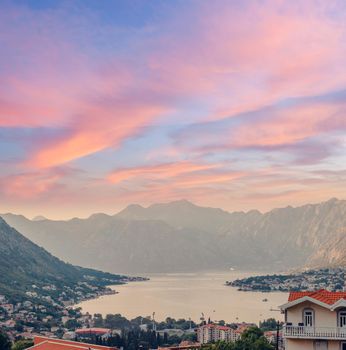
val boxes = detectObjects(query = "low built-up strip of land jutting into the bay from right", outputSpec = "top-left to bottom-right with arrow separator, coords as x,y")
226,268 -> 346,292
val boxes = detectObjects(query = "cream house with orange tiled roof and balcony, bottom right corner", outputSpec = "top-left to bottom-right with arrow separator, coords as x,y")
280,289 -> 346,350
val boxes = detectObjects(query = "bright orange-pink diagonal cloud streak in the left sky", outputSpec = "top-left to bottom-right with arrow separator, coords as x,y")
27,102 -> 167,168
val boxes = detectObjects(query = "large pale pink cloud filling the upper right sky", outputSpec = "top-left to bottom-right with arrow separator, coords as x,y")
150,1 -> 346,123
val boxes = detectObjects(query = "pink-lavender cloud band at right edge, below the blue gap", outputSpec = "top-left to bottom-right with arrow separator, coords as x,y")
176,96 -> 346,157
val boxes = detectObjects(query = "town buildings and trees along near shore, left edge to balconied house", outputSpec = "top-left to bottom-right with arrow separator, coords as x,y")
0,286 -> 282,349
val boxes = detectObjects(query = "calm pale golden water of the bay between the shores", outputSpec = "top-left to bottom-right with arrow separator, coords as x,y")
78,271 -> 288,323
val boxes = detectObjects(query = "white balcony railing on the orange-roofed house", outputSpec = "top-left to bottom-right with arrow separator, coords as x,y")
283,326 -> 346,340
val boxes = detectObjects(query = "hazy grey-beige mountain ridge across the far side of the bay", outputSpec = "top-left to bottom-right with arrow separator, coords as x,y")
2,199 -> 346,273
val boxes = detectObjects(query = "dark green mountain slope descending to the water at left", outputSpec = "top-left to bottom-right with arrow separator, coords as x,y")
0,218 -> 126,301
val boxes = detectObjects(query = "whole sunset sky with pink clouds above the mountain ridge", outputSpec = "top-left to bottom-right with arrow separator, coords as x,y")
0,0 -> 346,219
